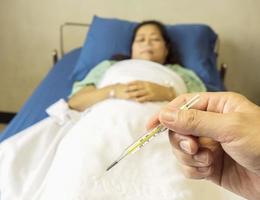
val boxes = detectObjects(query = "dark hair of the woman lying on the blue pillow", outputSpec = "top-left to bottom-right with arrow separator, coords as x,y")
112,20 -> 181,64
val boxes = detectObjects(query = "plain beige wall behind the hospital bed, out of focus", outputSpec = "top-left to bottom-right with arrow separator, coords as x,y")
0,0 -> 260,117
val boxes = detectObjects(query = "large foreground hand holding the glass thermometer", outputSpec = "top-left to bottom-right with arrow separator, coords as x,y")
148,92 -> 260,199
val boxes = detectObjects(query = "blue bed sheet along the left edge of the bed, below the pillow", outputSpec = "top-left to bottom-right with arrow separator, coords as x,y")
0,48 -> 81,142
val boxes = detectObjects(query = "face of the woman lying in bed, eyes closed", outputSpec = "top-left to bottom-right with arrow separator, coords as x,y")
131,24 -> 168,64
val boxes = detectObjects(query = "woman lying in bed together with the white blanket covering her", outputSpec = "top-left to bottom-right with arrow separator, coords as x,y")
0,19 -> 242,200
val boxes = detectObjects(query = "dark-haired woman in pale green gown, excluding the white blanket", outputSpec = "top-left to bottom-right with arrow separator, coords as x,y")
69,21 -> 205,111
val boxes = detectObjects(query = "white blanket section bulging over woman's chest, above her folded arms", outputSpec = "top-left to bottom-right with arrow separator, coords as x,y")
99,59 -> 187,95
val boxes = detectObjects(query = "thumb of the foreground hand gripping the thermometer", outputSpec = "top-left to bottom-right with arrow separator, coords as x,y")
159,108 -> 229,142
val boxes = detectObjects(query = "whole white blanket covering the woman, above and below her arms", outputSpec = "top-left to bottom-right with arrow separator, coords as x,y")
0,61 -> 244,200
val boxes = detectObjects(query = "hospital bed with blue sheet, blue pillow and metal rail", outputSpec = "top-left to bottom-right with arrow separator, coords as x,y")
0,16 -> 225,141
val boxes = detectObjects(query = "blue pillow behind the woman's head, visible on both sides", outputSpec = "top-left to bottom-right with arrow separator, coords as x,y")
72,16 -> 224,91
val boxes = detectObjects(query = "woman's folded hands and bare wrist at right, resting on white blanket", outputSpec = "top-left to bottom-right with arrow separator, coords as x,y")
127,81 -> 176,103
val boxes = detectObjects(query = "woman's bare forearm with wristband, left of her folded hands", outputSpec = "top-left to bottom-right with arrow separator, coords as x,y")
68,84 -> 129,111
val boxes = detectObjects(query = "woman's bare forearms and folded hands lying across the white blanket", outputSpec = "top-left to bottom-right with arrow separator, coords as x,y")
68,81 -> 176,111
